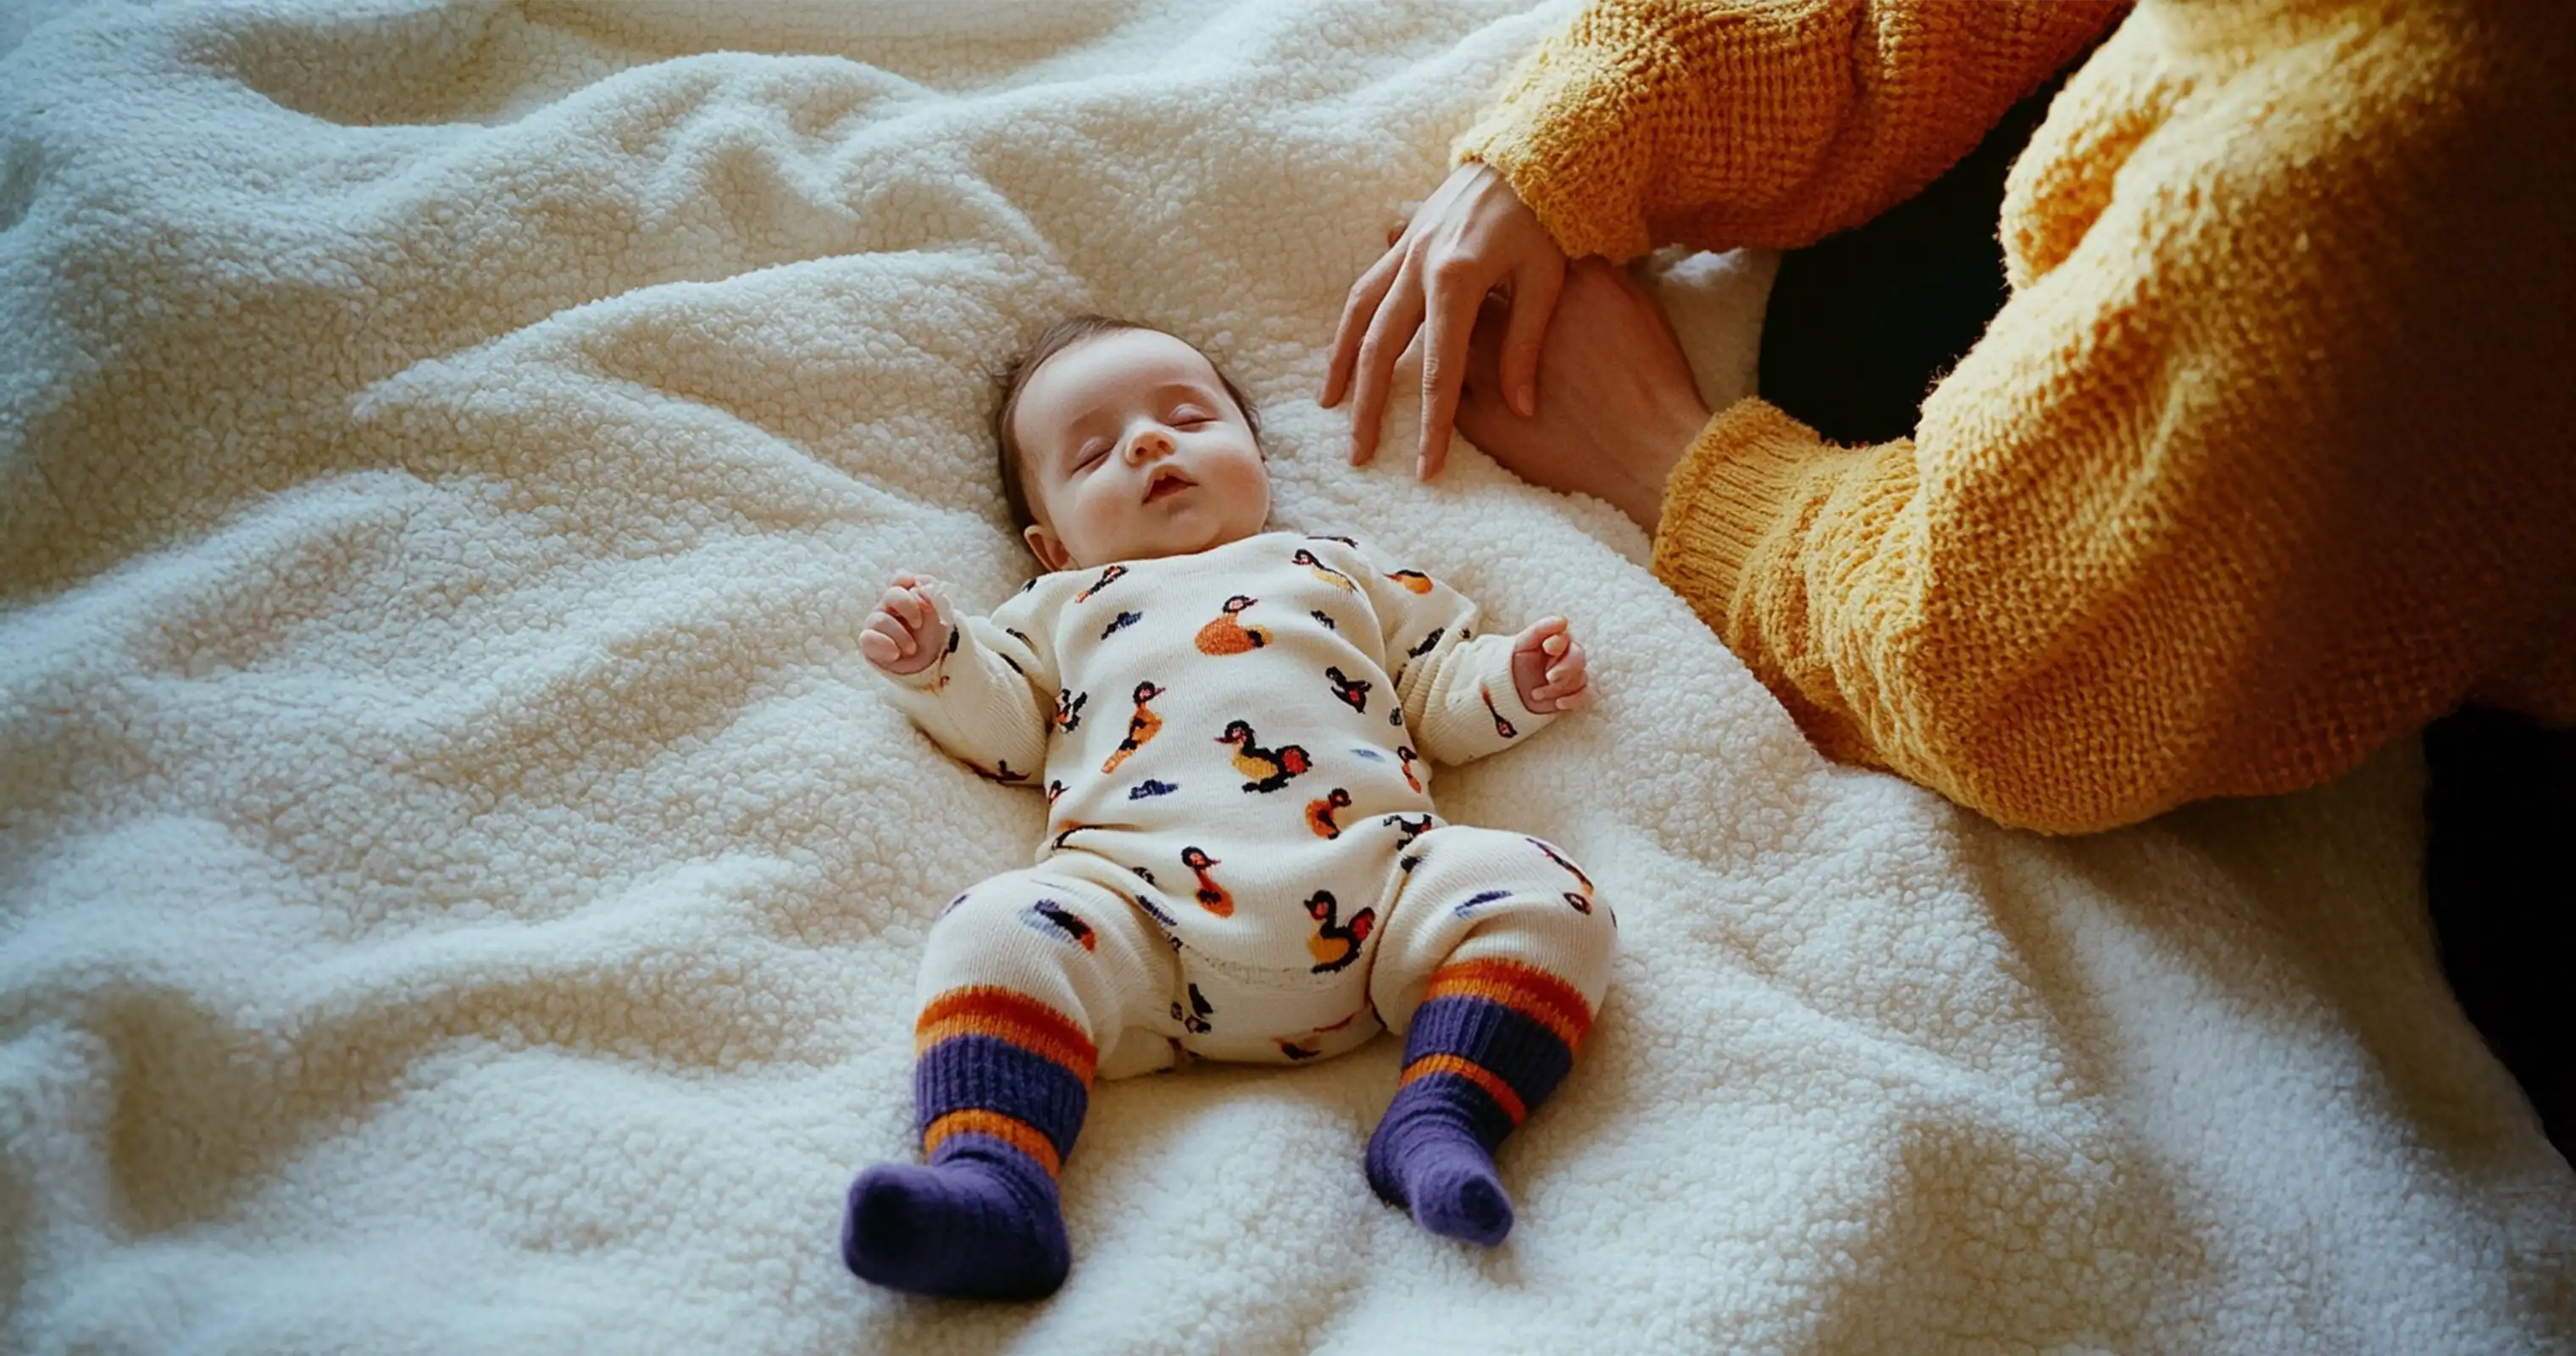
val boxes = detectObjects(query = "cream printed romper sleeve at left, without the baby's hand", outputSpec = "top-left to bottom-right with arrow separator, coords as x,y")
876,593 -> 1058,784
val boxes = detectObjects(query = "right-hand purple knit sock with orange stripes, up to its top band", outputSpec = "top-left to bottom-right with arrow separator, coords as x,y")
1368,957 -> 1592,1248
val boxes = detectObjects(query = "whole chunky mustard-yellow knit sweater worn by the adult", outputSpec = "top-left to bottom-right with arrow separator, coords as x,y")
1458,0 -> 2576,833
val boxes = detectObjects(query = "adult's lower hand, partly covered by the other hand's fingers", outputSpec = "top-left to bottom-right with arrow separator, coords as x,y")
1458,258 -> 1708,536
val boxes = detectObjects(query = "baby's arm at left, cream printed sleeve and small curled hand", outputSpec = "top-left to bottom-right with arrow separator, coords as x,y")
858,572 -> 1053,784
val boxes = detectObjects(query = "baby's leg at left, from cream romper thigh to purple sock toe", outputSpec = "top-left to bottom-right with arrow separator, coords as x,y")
840,871 -> 1174,1299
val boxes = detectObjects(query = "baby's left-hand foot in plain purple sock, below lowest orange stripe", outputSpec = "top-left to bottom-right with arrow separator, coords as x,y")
840,1150 -> 1072,1299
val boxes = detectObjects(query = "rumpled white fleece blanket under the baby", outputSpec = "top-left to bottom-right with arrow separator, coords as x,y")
0,0 -> 2576,1356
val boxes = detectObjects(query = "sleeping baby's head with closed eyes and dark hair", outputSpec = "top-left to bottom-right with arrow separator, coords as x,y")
1013,330 -> 1270,570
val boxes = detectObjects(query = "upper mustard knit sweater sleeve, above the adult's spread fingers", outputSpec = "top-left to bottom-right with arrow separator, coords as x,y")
1453,0 -> 2128,260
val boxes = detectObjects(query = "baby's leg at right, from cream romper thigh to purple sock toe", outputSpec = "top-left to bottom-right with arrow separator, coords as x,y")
1368,825 -> 1615,1245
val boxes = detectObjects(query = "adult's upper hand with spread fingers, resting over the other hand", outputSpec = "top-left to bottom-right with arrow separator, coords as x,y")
1322,165 -> 1566,480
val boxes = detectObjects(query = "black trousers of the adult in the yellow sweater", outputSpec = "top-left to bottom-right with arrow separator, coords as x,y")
1762,82 -> 2576,1160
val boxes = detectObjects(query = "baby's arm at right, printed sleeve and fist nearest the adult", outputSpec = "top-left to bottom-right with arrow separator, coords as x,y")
1368,548 -> 1590,763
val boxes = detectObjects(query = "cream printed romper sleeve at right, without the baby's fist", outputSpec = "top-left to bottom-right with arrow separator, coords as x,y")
1365,557 -> 1556,765
